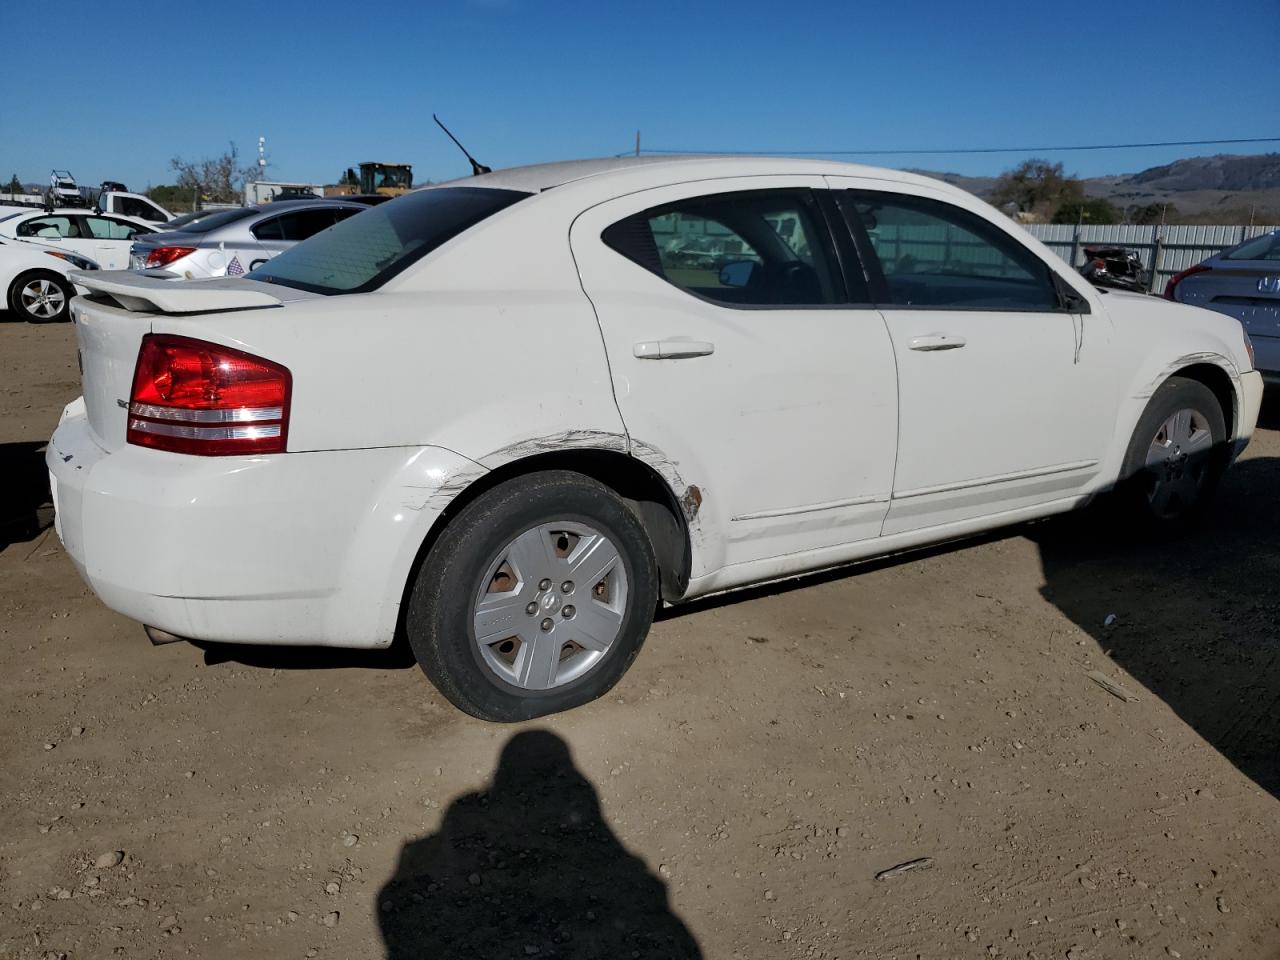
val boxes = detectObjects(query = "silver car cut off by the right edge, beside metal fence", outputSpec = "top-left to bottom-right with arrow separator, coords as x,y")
1165,230 -> 1280,383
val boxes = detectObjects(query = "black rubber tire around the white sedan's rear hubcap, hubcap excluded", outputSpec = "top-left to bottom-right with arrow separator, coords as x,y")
404,470 -> 658,722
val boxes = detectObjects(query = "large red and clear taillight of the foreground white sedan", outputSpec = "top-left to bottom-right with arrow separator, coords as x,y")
127,334 -> 293,457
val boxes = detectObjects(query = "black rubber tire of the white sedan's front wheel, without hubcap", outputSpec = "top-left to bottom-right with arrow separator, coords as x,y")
1117,376 -> 1229,534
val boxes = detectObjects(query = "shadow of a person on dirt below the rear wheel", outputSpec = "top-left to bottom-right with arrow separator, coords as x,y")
375,730 -> 701,960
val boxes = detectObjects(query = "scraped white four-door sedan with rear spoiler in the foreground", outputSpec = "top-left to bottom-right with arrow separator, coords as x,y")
47,157 -> 1262,721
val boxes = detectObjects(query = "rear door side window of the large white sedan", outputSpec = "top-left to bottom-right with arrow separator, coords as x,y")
602,189 -> 844,307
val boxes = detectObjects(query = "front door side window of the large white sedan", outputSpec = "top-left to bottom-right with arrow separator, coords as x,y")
841,191 -> 1059,310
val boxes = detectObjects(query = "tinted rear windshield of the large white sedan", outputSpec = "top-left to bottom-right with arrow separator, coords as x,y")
247,187 -> 529,293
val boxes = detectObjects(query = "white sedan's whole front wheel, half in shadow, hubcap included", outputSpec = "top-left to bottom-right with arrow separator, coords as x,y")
1120,376 -> 1228,531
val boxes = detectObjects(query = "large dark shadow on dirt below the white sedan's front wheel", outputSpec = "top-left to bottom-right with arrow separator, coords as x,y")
1025,457 -> 1280,799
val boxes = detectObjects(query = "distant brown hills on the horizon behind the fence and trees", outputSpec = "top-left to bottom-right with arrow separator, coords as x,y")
913,154 -> 1280,223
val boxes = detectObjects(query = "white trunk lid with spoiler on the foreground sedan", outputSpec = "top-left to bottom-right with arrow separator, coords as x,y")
70,271 -> 295,451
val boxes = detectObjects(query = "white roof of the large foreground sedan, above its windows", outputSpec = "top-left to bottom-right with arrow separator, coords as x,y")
428,154 -> 946,193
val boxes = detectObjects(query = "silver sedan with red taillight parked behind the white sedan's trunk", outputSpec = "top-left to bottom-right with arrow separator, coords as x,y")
129,200 -> 369,280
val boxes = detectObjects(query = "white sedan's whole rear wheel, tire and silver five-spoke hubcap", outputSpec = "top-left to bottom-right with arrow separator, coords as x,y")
404,470 -> 658,722
